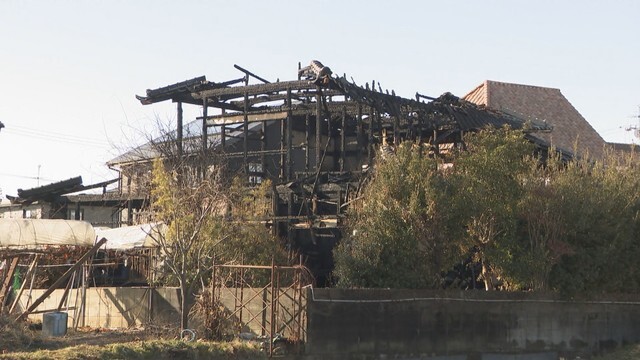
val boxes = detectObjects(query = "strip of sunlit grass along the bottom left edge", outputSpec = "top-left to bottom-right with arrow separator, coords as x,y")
0,340 -> 267,360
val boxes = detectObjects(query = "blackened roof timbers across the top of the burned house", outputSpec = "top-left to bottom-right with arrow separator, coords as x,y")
136,60 -> 545,181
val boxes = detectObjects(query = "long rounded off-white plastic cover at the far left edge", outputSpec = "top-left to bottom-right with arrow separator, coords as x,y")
0,219 -> 96,248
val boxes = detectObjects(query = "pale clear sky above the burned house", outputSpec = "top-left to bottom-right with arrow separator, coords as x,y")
0,0 -> 640,198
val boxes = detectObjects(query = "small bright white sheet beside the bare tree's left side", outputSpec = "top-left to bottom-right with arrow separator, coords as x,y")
96,223 -> 164,250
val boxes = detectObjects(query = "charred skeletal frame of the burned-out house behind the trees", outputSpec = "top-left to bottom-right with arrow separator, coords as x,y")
108,61 -> 546,284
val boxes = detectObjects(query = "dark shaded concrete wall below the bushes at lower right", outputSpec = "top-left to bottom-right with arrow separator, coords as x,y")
305,289 -> 640,359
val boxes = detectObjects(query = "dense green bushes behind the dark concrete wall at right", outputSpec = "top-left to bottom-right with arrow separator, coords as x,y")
334,128 -> 640,294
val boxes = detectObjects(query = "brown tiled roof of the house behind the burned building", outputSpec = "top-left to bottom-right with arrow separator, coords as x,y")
464,80 -> 605,159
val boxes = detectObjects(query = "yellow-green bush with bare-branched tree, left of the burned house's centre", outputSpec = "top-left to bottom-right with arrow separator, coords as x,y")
145,121 -> 287,329
